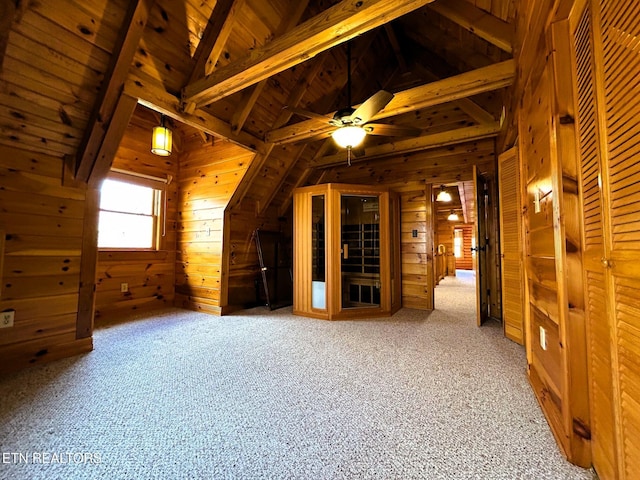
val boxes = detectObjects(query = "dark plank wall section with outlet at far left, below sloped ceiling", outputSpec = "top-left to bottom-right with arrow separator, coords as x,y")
0,146 -> 92,373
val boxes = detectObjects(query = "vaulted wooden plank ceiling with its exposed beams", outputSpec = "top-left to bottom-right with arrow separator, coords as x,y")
0,0 -> 515,212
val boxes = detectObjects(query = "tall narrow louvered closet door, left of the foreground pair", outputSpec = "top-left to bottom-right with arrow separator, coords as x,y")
574,4 -> 617,480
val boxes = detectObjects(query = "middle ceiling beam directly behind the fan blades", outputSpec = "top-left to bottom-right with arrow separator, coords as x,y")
265,60 -> 515,144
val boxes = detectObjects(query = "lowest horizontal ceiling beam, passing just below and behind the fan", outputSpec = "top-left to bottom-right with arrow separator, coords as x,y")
315,122 -> 500,168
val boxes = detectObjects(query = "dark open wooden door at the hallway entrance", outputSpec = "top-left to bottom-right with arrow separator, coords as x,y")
472,165 -> 489,326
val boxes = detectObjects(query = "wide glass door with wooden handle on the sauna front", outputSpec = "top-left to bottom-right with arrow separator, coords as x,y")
340,194 -> 380,309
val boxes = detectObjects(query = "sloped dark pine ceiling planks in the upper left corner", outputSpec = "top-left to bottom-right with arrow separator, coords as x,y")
0,0 -> 126,161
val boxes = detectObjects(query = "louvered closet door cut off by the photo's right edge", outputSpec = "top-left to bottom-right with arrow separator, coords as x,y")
600,0 -> 640,479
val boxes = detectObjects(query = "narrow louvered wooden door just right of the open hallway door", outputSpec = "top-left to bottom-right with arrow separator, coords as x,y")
498,147 -> 525,345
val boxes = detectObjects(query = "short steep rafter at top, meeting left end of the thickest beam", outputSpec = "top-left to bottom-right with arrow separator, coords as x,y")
187,0 -> 245,83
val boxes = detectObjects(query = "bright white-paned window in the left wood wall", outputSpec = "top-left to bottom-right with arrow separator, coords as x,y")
98,174 -> 164,250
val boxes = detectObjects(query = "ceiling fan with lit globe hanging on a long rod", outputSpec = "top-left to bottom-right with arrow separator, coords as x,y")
286,42 -> 420,166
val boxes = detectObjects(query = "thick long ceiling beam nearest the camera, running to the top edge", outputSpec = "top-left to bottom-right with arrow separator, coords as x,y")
182,0 -> 433,111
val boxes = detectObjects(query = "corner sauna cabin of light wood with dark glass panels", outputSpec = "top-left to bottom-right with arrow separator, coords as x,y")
293,183 -> 400,320
